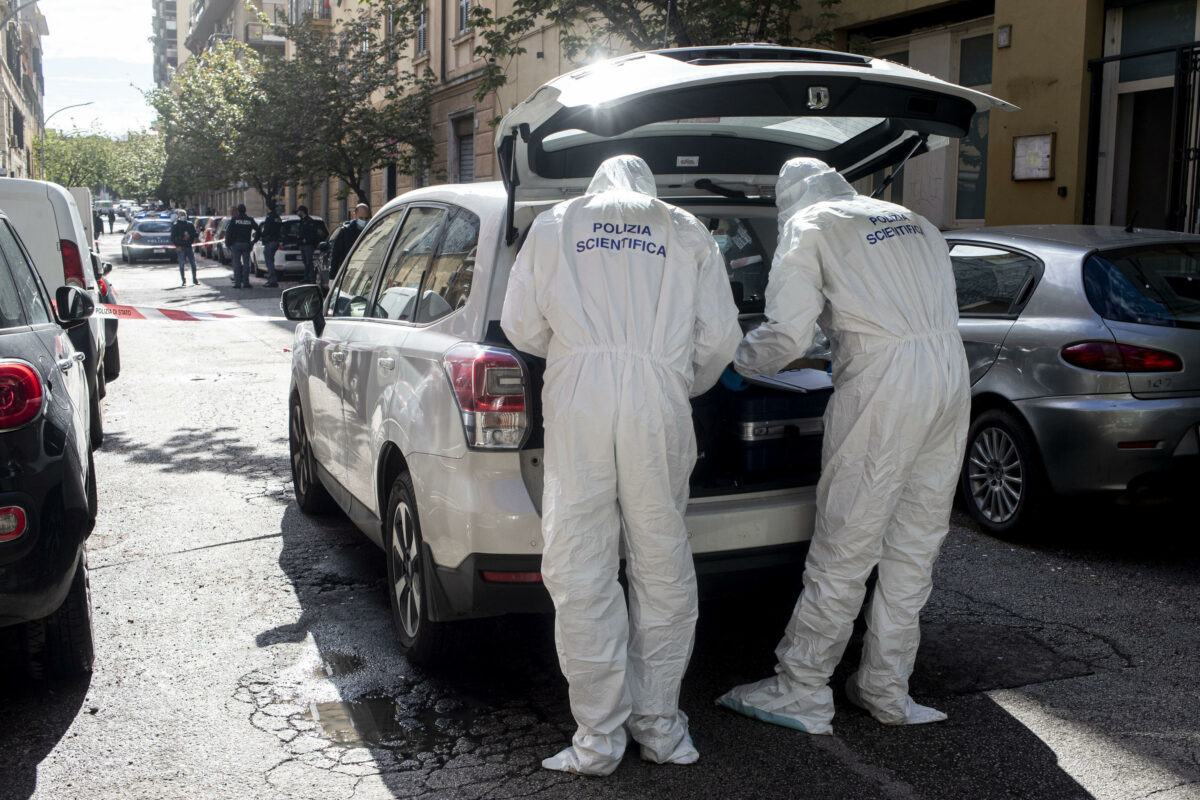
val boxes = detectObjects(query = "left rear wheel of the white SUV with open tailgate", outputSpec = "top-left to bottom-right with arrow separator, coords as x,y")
384,473 -> 456,664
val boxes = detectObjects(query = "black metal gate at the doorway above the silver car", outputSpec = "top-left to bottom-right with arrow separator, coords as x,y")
1084,42 -> 1200,233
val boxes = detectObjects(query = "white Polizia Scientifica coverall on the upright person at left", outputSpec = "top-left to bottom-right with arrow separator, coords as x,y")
500,156 -> 742,775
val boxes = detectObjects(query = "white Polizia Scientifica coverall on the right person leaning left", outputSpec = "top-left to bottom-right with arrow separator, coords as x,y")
718,158 -> 970,734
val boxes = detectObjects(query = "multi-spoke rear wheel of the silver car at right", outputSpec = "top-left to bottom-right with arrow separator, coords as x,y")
959,409 -> 1045,536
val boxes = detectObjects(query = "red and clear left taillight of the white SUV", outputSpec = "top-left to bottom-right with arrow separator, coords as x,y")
442,344 -> 528,450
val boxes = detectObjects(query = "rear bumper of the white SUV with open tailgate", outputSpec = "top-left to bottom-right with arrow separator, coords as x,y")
408,451 -> 816,620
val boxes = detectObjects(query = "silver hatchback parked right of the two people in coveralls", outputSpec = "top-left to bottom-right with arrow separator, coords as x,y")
946,225 -> 1200,534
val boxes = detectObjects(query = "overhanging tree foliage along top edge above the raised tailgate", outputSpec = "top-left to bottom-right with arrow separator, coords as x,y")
472,0 -> 841,107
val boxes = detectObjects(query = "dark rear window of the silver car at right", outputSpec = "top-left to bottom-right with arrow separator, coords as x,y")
1084,245 -> 1200,327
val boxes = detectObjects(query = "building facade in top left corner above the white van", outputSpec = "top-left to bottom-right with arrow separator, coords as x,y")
0,0 -> 49,178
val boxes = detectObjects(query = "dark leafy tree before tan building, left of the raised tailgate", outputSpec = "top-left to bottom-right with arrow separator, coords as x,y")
271,0 -> 433,203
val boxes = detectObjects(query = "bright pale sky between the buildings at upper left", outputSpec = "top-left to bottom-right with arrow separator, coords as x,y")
37,0 -> 154,136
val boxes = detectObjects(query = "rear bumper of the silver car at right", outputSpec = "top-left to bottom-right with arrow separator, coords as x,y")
1016,395 -> 1200,494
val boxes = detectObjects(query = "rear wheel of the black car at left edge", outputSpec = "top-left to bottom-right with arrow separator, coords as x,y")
22,551 -> 95,680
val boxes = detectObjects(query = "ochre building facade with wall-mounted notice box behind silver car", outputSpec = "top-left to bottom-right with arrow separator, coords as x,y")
838,0 -> 1200,231
